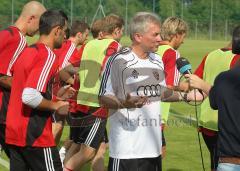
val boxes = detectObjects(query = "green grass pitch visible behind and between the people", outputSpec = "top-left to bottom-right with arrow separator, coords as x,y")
0,38 -> 228,171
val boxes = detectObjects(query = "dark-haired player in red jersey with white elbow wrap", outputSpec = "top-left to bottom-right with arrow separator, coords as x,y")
6,10 -> 69,171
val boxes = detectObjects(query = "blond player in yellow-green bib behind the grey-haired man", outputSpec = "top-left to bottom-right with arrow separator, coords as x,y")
156,17 -> 187,157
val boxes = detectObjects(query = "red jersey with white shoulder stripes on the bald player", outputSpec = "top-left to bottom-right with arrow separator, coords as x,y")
0,26 -> 27,123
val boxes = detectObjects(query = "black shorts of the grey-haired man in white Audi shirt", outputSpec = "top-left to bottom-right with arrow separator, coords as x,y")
108,156 -> 162,171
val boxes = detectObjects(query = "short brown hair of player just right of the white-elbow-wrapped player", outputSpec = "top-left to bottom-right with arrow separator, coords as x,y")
70,20 -> 90,36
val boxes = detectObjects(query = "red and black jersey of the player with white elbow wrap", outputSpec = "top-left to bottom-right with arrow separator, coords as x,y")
6,43 -> 58,147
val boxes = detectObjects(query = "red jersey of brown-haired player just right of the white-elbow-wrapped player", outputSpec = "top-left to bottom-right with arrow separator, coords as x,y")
54,40 -> 78,70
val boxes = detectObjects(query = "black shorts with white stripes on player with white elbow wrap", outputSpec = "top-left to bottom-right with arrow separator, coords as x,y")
9,145 -> 63,171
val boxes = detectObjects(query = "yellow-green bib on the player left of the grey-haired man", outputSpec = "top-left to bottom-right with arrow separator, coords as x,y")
77,39 -> 115,107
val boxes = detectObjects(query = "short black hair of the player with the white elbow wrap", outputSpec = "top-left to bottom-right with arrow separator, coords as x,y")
39,10 -> 68,35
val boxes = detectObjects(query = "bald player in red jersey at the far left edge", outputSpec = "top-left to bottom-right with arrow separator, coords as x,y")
0,1 -> 46,157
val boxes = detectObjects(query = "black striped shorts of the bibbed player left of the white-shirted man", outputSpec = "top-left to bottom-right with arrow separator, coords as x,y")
70,113 -> 107,149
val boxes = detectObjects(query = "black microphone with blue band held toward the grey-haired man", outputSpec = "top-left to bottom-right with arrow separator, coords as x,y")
176,57 -> 192,75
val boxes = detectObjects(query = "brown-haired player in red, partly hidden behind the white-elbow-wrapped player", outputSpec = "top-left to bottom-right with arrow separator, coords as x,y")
53,20 -> 90,162
